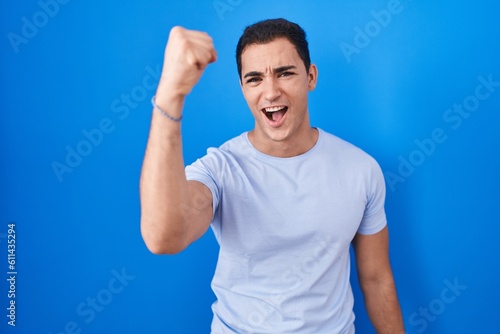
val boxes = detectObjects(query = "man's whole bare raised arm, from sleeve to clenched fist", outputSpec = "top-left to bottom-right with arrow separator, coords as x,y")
140,27 -> 217,253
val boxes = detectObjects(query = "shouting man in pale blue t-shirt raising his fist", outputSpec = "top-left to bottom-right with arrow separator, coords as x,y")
141,19 -> 404,334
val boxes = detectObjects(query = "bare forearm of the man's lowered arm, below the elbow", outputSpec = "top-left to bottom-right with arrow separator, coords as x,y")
362,275 -> 405,334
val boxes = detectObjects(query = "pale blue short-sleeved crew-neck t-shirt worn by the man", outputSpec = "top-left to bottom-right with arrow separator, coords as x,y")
186,129 -> 386,334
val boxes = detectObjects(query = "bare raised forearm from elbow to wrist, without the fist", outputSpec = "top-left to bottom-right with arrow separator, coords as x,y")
140,96 -> 189,253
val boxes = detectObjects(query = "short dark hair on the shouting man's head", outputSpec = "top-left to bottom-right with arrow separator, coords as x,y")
236,19 -> 311,80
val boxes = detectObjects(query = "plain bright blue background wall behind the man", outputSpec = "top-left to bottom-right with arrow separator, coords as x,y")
0,0 -> 500,334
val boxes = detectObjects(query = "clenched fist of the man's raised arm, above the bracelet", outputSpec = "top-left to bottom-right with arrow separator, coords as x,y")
157,27 -> 217,96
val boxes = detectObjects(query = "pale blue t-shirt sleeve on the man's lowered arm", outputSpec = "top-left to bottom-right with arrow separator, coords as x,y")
358,159 -> 387,235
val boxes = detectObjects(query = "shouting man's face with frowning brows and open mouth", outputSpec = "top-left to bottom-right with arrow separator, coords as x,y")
241,38 -> 317,143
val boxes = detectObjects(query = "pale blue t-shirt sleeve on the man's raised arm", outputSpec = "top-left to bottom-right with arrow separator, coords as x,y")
185,148 -> 222,215
